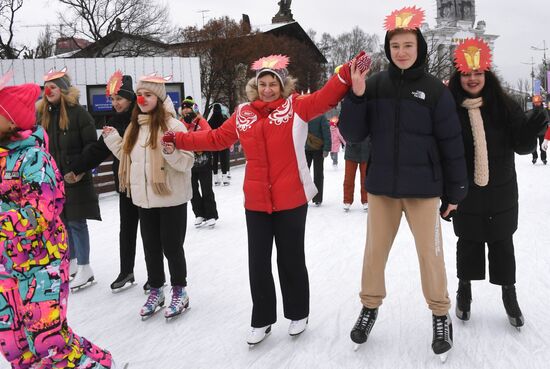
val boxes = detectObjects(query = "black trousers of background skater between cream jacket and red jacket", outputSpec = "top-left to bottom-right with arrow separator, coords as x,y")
191,166 -> 218,219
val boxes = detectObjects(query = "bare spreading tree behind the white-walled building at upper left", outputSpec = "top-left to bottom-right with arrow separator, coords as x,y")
58,0 -> 175,56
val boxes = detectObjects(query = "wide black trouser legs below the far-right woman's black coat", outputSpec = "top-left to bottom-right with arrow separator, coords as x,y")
456,236 -> 516,286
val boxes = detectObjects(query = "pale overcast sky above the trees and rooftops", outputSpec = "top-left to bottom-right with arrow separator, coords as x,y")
17,0 -> 550,87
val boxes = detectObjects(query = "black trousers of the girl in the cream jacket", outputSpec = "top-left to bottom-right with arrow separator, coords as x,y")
139,203 -> 187,288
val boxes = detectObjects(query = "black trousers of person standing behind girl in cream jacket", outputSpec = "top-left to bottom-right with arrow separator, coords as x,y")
118,193 -> 139,274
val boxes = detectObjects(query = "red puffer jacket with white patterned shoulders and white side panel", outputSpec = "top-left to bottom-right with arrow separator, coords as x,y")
176,75 -> 348,213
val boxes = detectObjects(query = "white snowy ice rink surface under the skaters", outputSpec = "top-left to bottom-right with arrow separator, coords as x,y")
5,153 -> 550,369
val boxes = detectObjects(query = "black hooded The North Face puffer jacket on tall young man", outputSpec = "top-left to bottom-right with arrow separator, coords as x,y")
339,31 -> 468,204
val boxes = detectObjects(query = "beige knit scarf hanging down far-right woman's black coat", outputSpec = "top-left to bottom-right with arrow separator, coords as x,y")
462,97 -> 489,186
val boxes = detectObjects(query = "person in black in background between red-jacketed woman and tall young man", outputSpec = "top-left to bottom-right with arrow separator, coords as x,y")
305,114 -> 332,206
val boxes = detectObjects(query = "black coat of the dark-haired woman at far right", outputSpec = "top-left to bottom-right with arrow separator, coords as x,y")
453,101 -> 538,242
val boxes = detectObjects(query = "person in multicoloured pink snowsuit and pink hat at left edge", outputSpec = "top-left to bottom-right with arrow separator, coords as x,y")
0,78 -> 113,369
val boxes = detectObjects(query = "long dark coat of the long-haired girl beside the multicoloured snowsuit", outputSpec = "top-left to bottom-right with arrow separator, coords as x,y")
38,92 -> 101,220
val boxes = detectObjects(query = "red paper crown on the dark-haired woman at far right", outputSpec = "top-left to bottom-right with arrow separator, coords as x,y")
455,38 -> 491,73
